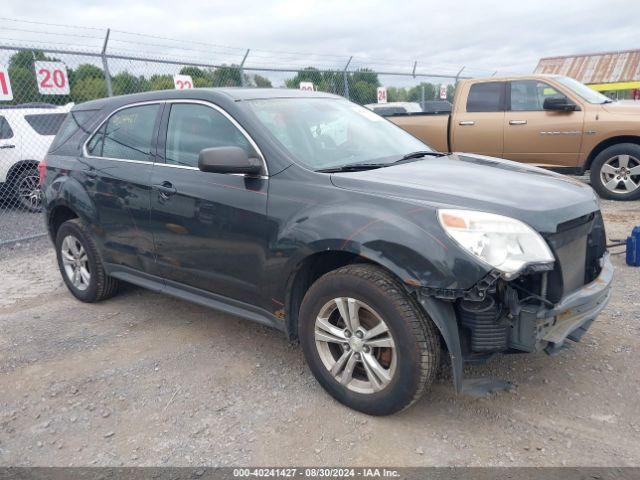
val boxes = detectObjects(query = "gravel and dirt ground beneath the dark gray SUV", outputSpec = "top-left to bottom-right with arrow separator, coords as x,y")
0,198 -> 640,466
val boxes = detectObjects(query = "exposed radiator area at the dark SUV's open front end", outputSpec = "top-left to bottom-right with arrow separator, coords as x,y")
545,212 -> 606,303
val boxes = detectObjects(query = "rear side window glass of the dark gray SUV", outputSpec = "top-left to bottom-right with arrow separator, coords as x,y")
87,105 -> 160,162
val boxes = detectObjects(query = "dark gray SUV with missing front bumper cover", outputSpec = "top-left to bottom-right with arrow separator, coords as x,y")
41,89 -> 612,415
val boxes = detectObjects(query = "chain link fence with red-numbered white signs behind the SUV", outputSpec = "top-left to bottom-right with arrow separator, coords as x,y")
0,39 -> 470,245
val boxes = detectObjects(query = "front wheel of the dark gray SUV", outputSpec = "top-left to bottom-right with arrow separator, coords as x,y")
299,265 -> 440,415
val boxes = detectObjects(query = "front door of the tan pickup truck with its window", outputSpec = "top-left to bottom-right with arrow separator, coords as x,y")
504,80 -> 584,167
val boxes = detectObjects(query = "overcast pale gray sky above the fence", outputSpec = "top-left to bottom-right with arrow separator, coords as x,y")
0,0 -> 640,79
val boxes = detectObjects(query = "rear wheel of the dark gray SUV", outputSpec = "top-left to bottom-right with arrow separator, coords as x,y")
56,219 -> 118,303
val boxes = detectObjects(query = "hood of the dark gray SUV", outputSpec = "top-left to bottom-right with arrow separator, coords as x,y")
331,154 -> 599,232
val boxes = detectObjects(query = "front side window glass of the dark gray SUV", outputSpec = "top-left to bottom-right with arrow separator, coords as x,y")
166,103 -> 253,167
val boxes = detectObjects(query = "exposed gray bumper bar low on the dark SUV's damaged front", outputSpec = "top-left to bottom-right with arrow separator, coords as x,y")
538,252 -> 613,348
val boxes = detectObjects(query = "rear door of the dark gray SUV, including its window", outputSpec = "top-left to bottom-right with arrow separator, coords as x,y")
79,103 -> 163,271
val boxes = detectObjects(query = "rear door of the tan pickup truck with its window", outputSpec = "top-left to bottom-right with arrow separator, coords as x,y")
450,82 -> 506,157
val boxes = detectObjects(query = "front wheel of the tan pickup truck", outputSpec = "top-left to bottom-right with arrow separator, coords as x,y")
591,143 -> 640,200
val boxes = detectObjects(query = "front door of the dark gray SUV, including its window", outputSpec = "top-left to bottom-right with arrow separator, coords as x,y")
151,102 -> 268,306
